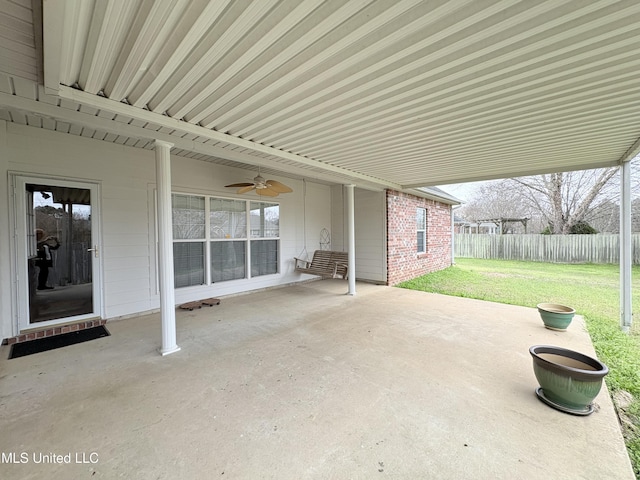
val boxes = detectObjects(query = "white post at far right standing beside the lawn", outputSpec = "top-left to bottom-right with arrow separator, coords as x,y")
620,161 -> 633,333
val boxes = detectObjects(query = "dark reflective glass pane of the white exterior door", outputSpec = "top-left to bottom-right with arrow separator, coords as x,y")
25,184 -> 93,323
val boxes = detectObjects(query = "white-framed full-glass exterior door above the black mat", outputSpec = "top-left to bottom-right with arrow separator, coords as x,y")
13,175 -> 102,331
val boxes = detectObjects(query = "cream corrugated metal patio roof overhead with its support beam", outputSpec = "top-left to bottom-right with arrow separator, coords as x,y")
0,0 -> 640,190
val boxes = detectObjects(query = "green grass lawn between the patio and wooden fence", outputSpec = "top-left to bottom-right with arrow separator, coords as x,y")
398,258 -> 640,479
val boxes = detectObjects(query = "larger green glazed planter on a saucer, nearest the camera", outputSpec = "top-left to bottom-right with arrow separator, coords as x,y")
529,345 -> 609,415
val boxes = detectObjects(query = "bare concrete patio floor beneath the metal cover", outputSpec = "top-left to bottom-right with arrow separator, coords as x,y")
0,280 -> 634,480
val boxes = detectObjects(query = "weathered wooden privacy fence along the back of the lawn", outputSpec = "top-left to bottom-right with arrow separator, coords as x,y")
454,233 -> 640,265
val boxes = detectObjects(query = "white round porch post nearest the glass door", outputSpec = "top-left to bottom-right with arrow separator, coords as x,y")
156,140 -> 180,355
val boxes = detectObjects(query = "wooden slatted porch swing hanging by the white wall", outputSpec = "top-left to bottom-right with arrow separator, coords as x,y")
294,179 -> 349,279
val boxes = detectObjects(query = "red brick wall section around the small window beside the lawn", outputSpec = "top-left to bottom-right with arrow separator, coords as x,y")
387,190 -> 451,285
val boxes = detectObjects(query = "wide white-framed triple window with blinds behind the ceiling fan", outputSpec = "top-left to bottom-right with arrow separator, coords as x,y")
172,194 -> 280,288
